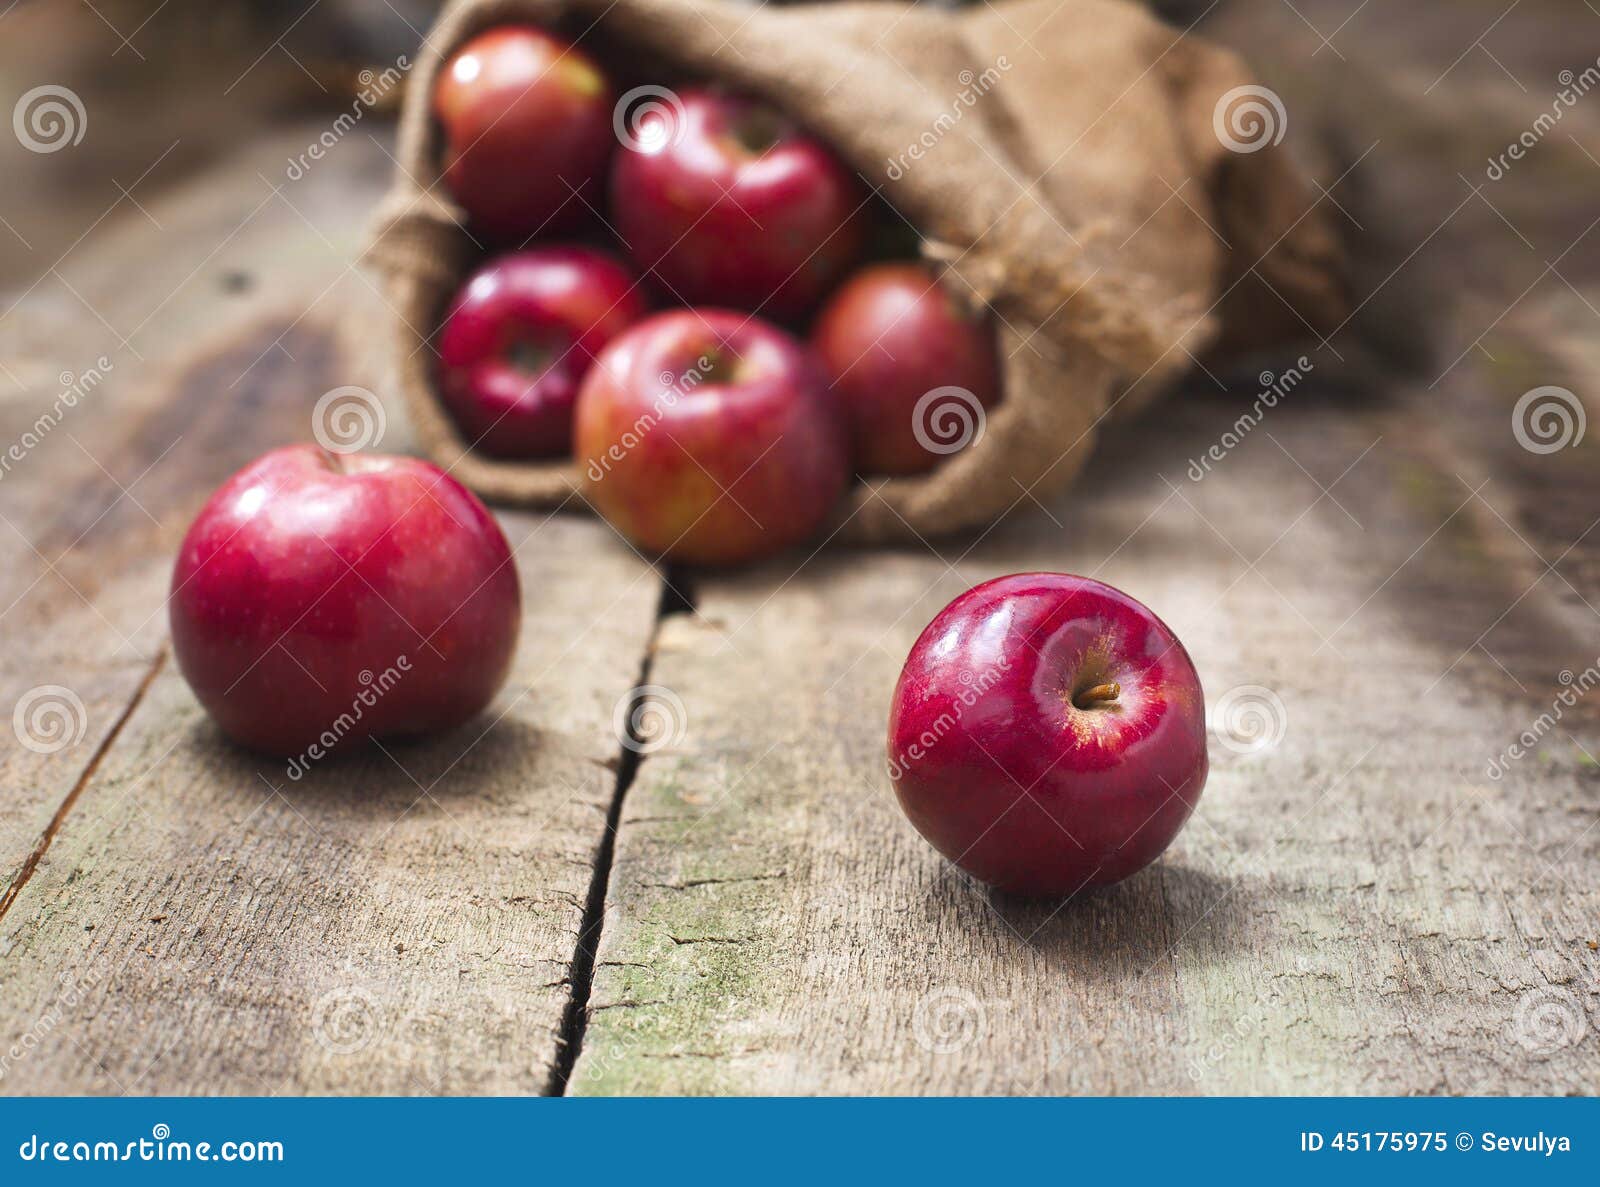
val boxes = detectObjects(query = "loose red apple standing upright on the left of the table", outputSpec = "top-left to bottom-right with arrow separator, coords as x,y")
170,445 -> 522,757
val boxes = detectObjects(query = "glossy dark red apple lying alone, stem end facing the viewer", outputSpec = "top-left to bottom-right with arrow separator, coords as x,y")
888,573 -> 1208,896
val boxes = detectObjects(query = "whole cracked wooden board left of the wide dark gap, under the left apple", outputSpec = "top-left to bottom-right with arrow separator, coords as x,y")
0,115 -> 659,1093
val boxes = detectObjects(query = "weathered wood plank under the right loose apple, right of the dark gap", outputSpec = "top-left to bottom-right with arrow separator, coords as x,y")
573,380 -> 1600,1093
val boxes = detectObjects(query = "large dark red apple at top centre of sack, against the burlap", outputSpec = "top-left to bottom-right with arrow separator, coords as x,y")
611,90 -> 866,320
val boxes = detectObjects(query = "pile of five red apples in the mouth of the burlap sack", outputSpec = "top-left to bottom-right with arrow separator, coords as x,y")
432,24 -> 1000,563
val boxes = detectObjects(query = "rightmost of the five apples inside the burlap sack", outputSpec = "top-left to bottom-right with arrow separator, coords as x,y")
811,264 -> 1000,475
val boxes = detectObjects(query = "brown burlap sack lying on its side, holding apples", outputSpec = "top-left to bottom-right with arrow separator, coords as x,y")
363,0 -> 1344,541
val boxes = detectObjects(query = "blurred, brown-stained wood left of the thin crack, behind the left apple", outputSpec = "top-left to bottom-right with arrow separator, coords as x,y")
0,123 -> 405,894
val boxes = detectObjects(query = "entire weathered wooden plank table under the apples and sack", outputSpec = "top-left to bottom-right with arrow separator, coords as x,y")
0,0 -> 1600,1094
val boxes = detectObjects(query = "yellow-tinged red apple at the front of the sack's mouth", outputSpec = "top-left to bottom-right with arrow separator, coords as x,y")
574,309 -> 850,565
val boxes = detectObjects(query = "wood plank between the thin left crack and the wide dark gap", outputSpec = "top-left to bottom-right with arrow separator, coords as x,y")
0,515 -> 658,1093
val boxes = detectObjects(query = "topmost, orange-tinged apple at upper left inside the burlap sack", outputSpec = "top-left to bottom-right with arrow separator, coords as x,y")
434,24 -> 616,242
